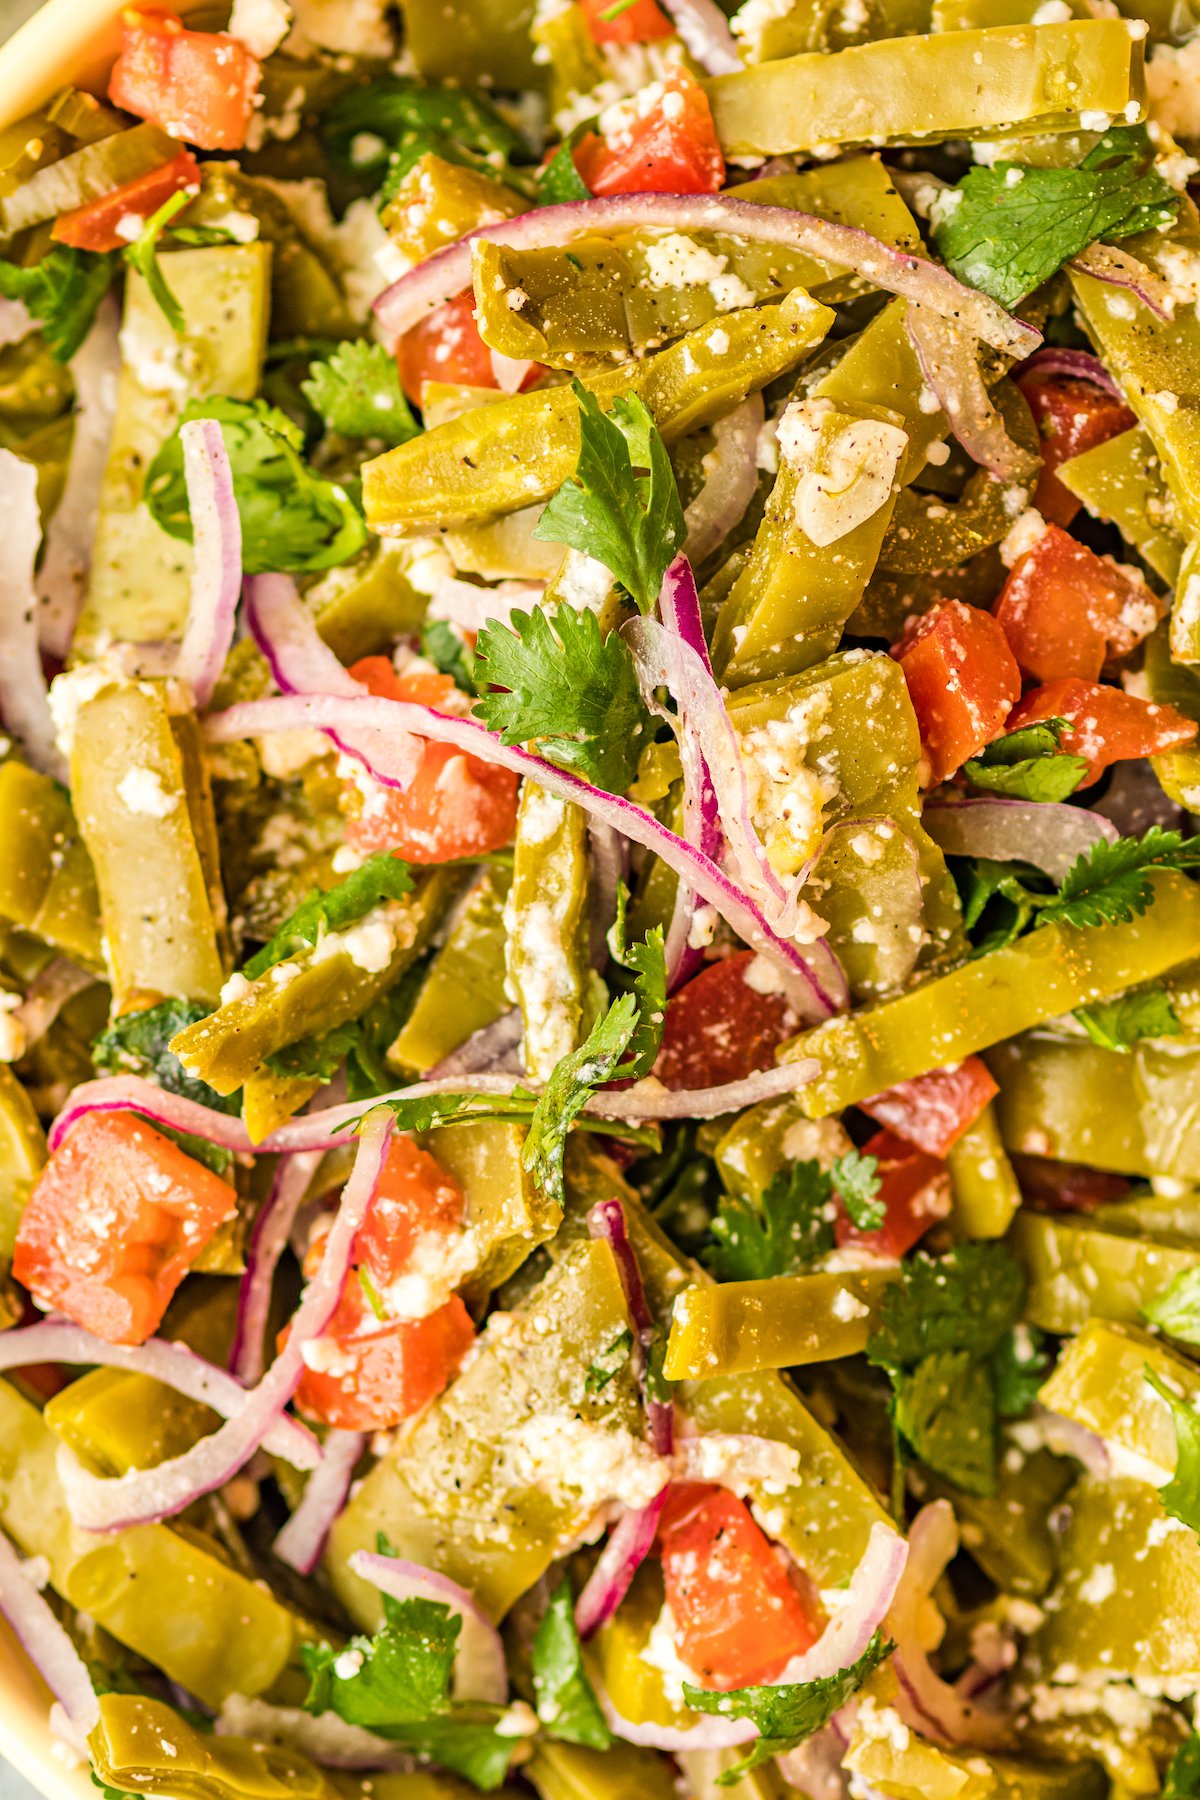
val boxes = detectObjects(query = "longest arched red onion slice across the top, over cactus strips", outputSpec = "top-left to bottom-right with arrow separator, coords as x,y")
374,194 -> 1040,356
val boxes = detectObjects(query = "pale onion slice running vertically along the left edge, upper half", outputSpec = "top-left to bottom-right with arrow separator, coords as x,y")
0,450 -> 67,781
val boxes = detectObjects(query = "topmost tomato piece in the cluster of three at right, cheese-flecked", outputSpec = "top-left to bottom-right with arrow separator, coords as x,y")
995,526 -> 1162,680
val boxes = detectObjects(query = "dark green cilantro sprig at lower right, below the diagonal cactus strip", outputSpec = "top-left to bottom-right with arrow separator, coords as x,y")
867,1244 -> 1040,1494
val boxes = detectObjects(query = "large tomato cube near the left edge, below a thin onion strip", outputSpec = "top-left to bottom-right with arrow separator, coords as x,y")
13,1112 -> 236,1345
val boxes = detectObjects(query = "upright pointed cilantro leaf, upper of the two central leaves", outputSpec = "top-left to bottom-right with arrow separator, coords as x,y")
533,382 -> 685,612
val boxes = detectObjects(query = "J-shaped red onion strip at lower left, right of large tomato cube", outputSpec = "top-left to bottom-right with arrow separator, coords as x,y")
61,1107 -> 394,1532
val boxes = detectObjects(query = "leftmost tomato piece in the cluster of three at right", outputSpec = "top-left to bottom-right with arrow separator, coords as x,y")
892,599 -> 1020,781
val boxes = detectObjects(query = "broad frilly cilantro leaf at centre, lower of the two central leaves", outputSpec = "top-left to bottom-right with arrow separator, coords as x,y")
475,605 -> 651,794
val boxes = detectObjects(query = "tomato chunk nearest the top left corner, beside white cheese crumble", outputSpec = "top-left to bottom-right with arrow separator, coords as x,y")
108,7 -> 261,149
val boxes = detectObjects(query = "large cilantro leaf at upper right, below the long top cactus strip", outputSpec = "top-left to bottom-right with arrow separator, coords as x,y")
932,126 -> 1178,306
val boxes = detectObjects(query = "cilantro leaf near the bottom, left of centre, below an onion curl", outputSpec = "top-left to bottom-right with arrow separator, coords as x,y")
300,1595 -> 462,1732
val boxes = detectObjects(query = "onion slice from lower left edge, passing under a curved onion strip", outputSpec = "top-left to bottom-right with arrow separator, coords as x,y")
0,1319 -> 320,1469
